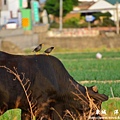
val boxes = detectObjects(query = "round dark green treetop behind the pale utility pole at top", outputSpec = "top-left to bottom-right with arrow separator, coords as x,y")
44,0 -> 73,17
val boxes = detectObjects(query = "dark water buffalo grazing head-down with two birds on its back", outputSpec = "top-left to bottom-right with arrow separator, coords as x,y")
0,51 -> 108,120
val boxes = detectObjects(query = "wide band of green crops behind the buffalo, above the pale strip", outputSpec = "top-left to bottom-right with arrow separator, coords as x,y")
56,52 -> 120,81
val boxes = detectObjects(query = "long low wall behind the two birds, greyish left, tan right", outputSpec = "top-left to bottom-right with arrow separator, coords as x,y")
0,25 -> 120,53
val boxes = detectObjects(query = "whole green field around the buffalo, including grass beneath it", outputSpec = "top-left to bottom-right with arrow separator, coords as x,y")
0,52 -> 120,120
